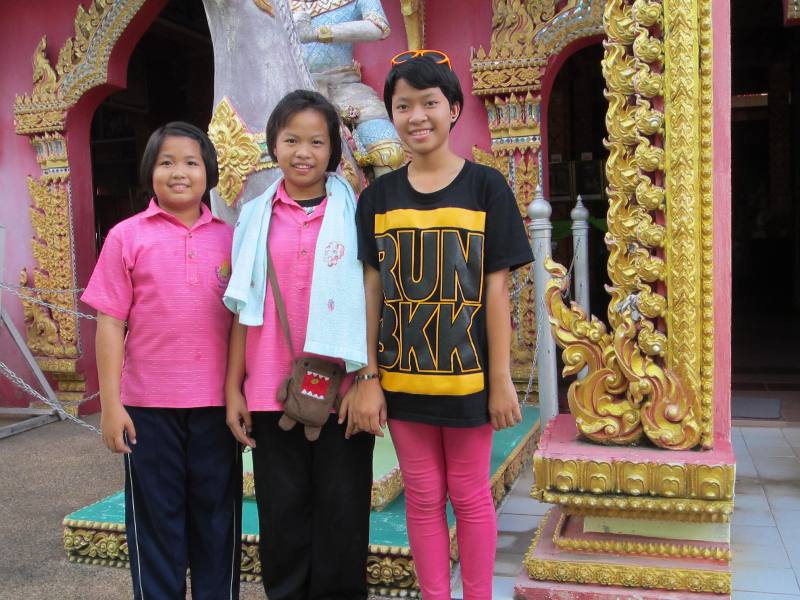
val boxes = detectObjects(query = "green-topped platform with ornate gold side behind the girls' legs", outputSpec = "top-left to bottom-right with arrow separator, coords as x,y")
64,406 -> 539,597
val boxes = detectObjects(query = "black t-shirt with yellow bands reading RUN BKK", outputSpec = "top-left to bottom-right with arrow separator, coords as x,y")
357,161 -> 533,427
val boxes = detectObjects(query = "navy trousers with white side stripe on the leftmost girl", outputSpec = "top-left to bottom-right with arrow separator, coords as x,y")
125,407 -> 242,600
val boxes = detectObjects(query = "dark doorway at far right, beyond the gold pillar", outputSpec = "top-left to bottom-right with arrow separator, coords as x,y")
731,0 -> 800,421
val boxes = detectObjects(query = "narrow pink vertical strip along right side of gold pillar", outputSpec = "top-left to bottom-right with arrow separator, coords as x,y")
712,0 -> 731,441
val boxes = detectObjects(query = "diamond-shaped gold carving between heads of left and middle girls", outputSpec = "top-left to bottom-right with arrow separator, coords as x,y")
208,96 -> 261,206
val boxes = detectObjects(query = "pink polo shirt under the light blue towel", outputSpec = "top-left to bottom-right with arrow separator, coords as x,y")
244,184 -> 355,411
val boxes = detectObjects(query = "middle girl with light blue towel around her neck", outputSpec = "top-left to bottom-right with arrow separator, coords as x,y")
225,90 -> 375,600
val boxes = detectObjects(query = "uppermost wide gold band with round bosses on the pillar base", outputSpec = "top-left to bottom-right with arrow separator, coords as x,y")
533,455 -> 736,502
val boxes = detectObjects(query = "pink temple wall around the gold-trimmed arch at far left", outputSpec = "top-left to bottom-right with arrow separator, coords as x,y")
0,0 -> 167,413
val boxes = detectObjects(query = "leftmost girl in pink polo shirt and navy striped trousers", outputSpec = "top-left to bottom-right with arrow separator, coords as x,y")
82,122 -> 242,600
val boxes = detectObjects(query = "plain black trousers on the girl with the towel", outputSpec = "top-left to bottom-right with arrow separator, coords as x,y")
252,412 -> 375,600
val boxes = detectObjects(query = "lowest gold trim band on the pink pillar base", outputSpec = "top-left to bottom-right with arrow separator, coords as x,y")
523,509 -> 731,594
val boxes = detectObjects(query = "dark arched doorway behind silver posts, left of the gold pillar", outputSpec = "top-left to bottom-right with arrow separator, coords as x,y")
547,43 -> 609,322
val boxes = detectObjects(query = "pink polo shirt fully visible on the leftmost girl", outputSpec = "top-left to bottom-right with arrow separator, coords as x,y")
81,200 -> 232,408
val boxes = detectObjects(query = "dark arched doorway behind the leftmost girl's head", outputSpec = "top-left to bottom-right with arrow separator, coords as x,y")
90,0 -> 214,252
